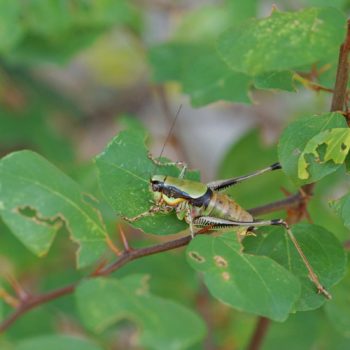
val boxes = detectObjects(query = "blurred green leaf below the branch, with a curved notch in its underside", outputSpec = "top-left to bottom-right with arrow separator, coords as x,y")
75,275 -> 205,350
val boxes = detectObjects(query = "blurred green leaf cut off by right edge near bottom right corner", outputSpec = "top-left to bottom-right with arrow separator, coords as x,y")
325,260 -> 350,338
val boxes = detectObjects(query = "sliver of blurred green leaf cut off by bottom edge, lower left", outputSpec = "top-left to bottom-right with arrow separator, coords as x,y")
16,335 -> 102,350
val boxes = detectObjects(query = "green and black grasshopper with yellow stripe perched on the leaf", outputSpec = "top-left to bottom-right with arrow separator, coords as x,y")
124,160 -> 331,299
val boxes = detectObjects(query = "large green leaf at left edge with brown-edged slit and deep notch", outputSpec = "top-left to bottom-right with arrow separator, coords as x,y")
0,151 -> 107,267
